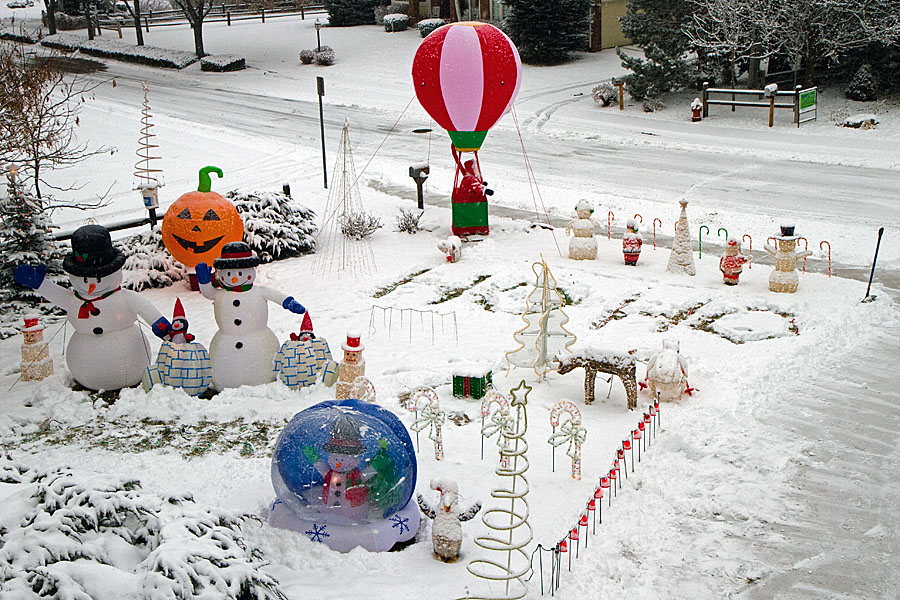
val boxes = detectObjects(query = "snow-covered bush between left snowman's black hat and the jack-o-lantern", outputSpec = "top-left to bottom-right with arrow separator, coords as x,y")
118,227 -> 188,292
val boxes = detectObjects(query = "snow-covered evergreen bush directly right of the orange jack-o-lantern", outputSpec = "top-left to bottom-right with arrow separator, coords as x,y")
225,191 -> 318,263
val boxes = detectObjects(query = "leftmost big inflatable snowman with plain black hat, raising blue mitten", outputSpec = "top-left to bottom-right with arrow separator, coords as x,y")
13,225 -> 169,390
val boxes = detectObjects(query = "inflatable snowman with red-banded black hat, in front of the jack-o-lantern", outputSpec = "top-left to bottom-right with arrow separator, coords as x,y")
197,242 -> 306,391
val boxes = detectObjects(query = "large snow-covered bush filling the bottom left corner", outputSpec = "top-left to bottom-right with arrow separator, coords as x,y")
0,456 -> 284,600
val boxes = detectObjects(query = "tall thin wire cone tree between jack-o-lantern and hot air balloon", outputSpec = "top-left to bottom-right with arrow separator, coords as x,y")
314,119 -> 380,275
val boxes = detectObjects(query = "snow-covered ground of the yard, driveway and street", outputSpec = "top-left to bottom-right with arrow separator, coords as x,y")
0,8 -> 900,599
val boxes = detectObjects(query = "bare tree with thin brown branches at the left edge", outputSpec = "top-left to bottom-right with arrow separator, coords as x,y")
0,43 -> 114,208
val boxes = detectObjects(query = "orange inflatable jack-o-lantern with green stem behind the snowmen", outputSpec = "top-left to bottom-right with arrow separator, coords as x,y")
162,167 -> 244,267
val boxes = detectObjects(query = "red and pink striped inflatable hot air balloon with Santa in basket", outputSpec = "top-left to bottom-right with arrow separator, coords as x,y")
412,22 -> 522,236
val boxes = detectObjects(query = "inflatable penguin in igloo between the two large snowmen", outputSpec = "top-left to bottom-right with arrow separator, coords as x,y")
142,298 -> 212,396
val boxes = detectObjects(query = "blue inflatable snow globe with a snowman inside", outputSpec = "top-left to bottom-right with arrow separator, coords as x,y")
269,399 -> 419,552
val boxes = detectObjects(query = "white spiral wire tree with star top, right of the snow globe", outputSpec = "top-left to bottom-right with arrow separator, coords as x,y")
466,380 -> 532,600
